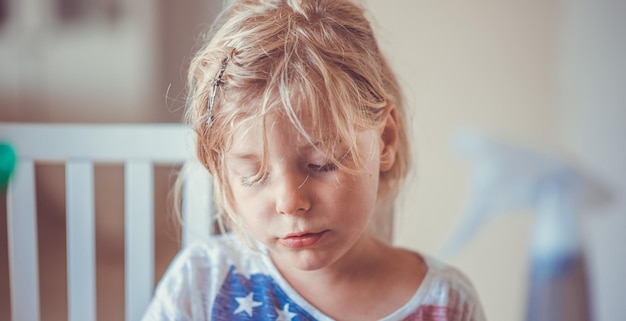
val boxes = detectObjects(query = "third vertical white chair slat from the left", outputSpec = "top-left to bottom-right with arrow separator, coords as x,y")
124,161 -> 154,321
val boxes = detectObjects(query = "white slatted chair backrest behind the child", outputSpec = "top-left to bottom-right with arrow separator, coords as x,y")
0,123 -> 213,321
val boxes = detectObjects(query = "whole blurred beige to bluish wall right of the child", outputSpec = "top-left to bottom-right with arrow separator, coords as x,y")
363,0 -> 626,321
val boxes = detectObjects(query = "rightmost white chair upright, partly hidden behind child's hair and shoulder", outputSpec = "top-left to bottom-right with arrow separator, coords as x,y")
183,160 -> 214,246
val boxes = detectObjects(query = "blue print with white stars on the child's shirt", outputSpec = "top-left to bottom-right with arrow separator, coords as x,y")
211,266 -> 316,321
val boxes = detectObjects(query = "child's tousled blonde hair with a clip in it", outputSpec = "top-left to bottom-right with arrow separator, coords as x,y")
185,0 -> 410,238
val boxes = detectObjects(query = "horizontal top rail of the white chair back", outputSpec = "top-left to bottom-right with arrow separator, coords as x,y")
0,122 -> 195,164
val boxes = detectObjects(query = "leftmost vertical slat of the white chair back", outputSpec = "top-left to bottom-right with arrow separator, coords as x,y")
7,161 -> 39,321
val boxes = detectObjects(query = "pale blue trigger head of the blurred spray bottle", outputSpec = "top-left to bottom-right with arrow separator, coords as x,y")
440,133 -> 607,258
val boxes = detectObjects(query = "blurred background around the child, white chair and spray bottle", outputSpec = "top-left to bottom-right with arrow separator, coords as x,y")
0,0 -> 626,321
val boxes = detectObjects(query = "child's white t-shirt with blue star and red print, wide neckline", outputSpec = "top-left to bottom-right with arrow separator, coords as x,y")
143,234 -> 485,321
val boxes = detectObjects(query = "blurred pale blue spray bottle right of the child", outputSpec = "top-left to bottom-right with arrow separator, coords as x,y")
441,133 -> 607,321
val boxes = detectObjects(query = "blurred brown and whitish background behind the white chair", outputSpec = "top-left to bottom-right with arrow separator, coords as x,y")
0,0 -> 222,321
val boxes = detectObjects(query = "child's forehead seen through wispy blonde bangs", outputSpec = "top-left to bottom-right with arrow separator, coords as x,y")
220,87 -> 356,154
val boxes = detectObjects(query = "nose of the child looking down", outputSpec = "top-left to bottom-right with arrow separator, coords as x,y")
276,171 -> 311,215
